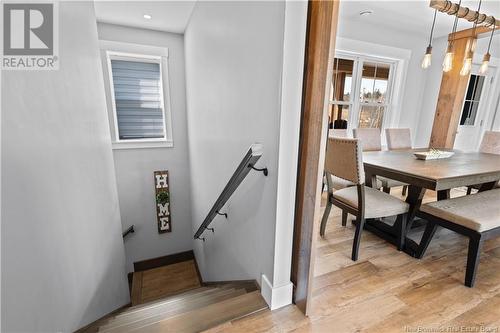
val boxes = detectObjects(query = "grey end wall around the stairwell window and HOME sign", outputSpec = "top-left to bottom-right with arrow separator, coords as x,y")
98,23 -> 193,271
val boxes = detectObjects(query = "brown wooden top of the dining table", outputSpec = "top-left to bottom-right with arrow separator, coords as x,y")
363,149 -> 500,190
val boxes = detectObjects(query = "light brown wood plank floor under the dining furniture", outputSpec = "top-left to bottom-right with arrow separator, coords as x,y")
211,189 -> 500,333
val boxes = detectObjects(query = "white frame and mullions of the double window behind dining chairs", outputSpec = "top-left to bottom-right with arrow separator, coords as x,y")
330,50 -> 398,133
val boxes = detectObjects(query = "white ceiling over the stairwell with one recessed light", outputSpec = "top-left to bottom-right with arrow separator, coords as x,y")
95,0 -> 195,33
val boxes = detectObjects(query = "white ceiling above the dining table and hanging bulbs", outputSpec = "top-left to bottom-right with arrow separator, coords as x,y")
340,0 -> 500,37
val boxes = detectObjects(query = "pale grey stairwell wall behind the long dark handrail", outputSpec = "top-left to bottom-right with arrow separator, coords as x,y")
185,2 -> 286,282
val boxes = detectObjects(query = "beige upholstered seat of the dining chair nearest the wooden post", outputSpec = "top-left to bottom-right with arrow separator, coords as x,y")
333,186 -> 409,219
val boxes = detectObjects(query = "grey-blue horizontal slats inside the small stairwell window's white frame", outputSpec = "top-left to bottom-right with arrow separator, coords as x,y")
111,59 -> 165,140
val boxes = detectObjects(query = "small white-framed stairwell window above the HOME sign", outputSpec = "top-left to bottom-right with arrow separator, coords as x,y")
106,51 -> 172,148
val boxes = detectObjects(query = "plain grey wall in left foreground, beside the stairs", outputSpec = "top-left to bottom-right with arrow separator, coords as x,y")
1,2 -> 129,332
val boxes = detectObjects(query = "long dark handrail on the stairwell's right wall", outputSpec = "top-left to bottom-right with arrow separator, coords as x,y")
194,144 -> 268,241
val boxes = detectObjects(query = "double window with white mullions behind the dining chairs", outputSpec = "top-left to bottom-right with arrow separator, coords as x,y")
330,56 -> 394,128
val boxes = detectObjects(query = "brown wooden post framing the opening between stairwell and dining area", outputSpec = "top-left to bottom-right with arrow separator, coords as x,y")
291,0 -> 340,315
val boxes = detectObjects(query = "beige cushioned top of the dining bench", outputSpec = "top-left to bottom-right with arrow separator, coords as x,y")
420,189 -> 500,232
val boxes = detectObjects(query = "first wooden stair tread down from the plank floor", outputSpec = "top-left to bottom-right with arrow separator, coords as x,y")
99,289 -> 246,333
